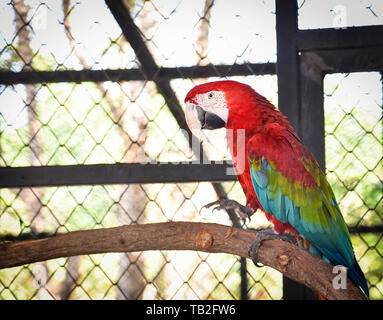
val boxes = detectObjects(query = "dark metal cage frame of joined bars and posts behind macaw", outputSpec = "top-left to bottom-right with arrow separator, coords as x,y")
0,0 -> 383,299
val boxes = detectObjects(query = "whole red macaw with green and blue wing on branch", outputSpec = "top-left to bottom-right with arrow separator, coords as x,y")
185,81 -> 369,297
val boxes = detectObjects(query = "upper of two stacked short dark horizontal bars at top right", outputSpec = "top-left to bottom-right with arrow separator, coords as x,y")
295,26 -> 383,51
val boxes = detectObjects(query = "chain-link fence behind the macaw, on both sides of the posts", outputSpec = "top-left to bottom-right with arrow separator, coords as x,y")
0,0 -> 383,299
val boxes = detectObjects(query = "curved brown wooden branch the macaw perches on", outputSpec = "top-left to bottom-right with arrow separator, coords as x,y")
0,222 -> 365,300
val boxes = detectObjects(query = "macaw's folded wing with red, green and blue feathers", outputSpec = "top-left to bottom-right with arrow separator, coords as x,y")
248,131 -> 368,295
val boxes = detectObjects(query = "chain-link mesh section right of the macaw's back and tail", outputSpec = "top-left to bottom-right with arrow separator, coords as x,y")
324,72 -> 383,299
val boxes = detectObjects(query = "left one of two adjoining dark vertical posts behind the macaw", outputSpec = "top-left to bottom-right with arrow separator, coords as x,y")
275,0 -> 313,300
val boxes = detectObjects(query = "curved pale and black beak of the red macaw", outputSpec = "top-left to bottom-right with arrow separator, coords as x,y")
185,102 -> 228,131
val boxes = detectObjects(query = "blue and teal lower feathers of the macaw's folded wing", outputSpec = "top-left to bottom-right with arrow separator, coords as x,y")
250,158 -> 368,296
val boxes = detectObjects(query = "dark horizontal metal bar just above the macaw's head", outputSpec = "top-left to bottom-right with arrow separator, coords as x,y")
0,63 -> 276,85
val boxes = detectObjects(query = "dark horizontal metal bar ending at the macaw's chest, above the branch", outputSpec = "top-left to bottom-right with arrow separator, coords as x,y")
0,162 -> 237,188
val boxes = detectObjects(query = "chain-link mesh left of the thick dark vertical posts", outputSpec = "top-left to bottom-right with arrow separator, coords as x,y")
0,0 -> 282,299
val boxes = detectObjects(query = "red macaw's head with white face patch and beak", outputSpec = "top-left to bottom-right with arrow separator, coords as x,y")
185,80 -> 275,133
